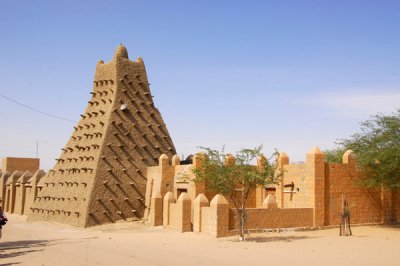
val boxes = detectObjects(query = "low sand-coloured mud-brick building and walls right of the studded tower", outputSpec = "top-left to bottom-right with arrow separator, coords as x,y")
146,147 -> 400,237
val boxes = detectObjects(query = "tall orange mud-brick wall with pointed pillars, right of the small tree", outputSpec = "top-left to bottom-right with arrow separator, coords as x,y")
276,148 -> 400,227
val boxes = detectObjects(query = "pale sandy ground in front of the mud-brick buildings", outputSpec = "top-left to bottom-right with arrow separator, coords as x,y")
0,215 -> 400,266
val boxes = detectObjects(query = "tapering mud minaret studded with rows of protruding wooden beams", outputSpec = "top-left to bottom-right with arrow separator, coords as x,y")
29,45 -> 176,227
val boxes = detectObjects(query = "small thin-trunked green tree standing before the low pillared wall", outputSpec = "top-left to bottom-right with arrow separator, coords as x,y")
194,146 -> 280,240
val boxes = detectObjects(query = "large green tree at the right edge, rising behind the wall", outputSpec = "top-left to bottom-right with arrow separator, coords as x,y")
339,109 -> 400,188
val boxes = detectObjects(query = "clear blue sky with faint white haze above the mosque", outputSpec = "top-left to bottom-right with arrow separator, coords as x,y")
0,0 -> 400,169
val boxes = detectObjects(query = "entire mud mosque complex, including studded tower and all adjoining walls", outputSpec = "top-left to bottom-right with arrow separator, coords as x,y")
0,45 -> 400,237
